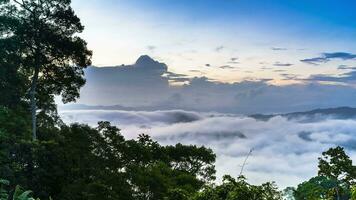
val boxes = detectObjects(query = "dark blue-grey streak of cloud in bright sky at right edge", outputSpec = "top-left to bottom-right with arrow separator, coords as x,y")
300,52 -> 356,65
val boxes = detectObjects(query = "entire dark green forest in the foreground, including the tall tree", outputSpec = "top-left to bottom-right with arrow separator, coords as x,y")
0,0 -> 356,200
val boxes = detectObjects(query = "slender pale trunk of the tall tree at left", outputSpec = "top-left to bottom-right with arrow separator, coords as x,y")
30,67 -> 40,141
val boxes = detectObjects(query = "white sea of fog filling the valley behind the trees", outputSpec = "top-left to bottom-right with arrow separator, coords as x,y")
60,110 -> 356,188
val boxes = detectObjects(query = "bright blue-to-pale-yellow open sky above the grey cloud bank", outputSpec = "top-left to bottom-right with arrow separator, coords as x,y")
73,0 -> 356,84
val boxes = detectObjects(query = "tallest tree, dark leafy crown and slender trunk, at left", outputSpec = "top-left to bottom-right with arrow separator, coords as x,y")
0,0 -> 92,140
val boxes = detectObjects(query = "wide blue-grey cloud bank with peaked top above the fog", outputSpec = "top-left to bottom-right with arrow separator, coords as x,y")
78,56 -> 356,114
